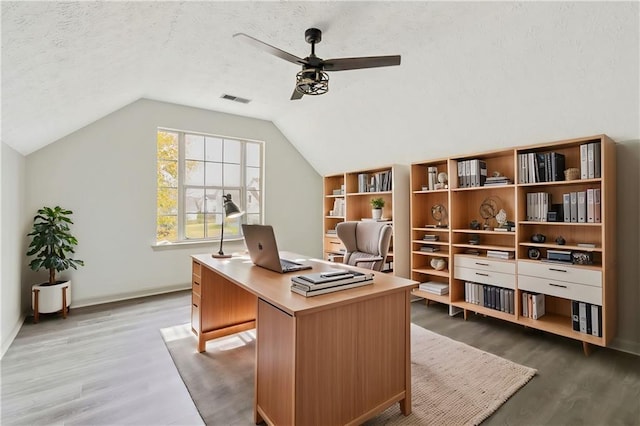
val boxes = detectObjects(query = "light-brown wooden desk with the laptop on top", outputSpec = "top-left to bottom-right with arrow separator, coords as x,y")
191,253 -> 418,426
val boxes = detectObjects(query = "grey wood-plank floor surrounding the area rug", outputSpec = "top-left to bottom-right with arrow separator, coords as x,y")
0,291 -> 640,425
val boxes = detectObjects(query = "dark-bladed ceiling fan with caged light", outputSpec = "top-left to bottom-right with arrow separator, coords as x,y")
233,28 -> 400,100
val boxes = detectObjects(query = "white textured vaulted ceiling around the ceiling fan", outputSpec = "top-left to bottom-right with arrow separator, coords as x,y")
2,1 -> 638,173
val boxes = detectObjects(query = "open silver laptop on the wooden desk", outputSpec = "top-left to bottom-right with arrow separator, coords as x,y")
242,224 -> 311,274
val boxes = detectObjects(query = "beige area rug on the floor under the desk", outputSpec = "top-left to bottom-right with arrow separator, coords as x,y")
160,324 -> 536,425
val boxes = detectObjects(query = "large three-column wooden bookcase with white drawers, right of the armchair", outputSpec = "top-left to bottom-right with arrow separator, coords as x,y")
410,135 -> 617,352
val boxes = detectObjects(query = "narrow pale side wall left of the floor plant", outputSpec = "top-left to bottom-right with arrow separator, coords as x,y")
0,143 -> 30,355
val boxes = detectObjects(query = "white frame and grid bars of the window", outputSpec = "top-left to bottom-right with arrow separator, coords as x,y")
155,126 -> 266,246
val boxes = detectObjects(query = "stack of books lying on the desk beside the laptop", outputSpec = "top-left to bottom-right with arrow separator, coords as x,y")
291,269 -> 373,297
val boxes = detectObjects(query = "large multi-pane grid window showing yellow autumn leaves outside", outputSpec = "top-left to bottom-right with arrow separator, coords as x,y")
156,129 -> 263,243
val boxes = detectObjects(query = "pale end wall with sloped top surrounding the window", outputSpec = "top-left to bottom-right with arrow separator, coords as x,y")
23,99 -> 322,307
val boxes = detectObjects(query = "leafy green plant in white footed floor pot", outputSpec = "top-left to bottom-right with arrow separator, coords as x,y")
27,206 -> 84,322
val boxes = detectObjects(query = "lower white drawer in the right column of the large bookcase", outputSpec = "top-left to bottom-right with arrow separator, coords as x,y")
518,275 -> 602,305
